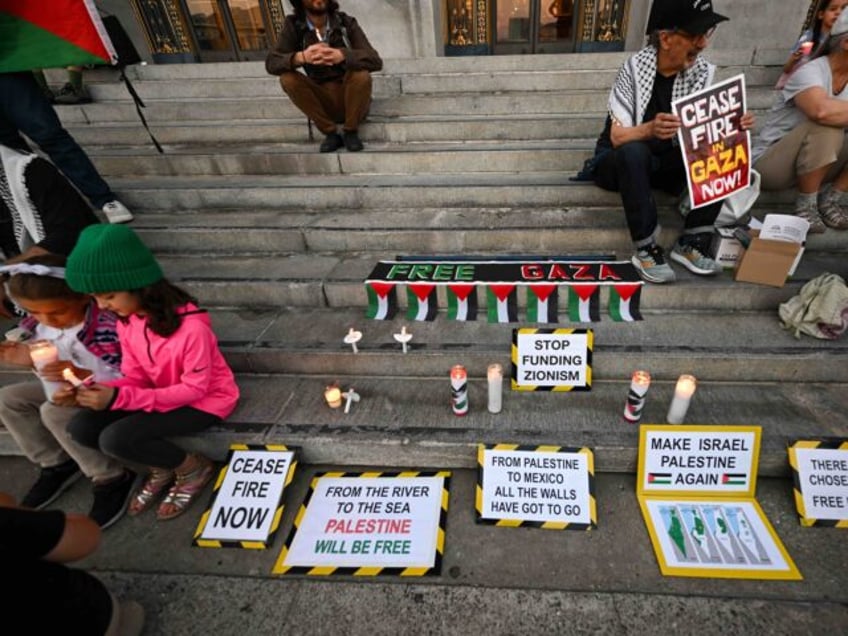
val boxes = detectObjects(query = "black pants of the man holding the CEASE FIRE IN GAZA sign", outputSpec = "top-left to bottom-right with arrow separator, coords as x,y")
595,141 -> 721,247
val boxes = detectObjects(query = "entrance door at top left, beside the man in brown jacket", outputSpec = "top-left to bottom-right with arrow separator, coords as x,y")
182,0 -> 276,62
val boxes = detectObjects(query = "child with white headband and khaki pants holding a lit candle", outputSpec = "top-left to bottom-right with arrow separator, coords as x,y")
0,254 -> 135,528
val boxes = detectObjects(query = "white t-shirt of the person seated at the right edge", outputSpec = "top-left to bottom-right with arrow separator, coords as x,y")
751,56 -> 848,163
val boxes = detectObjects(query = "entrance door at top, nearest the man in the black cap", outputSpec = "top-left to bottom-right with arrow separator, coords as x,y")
493,0 -> 577,55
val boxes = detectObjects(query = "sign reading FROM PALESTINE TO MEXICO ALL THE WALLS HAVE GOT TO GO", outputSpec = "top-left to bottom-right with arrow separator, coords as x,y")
476,444 -> 597,530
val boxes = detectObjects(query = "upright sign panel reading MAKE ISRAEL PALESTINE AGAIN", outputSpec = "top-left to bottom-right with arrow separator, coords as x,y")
639,425 -> 761,497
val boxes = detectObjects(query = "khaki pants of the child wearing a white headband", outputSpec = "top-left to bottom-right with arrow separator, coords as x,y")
0,382 -> 124,481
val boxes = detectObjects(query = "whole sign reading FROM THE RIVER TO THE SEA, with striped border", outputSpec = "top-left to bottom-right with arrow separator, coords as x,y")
273,472 -> 450,576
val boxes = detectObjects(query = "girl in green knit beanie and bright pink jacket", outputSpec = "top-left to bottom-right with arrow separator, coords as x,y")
67,225 -> 239,519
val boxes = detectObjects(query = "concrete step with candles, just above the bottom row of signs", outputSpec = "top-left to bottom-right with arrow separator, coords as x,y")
0,372 -> 848,472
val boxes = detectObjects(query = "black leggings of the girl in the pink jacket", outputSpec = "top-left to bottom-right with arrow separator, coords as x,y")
68,406 -> 221,470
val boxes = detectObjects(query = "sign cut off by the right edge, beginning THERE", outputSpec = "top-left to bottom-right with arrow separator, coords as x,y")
789,438 -> 848,528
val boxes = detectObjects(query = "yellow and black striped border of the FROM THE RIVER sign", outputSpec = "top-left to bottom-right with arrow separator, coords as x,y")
271,471 -> 451,577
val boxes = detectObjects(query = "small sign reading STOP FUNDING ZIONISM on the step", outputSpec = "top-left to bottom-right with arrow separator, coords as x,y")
511,329 -> 594,391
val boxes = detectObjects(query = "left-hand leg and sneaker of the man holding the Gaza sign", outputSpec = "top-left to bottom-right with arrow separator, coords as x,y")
595,142 -> 675,283
